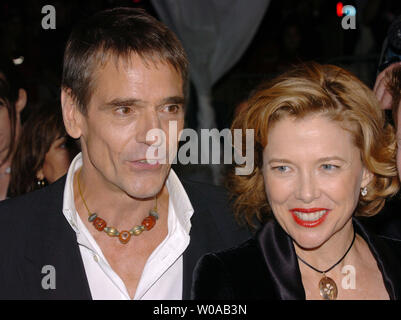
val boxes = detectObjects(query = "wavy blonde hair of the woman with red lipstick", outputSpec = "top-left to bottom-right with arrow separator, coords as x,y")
227,62 -> 399,227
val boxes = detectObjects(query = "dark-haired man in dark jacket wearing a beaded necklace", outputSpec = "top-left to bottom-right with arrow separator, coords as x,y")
0,8 -> 248,299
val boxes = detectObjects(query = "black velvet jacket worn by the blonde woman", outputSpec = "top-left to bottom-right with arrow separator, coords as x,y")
191,219 -> 401,300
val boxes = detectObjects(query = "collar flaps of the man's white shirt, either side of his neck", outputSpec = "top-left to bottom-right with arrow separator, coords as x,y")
63,152 -> 194,233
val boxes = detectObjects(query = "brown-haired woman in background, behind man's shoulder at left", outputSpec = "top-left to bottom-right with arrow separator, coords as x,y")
9,102 -> 79,197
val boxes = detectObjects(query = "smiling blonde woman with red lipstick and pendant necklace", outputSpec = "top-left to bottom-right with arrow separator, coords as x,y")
193,63 -> 401,300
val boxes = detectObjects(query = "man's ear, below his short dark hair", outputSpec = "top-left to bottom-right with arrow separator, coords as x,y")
61,89 -> 83,139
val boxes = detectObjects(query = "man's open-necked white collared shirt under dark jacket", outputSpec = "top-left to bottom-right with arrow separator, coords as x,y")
63,153 -> 194,300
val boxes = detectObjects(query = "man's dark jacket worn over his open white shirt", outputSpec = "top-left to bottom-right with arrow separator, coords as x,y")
0,177 -> 249,299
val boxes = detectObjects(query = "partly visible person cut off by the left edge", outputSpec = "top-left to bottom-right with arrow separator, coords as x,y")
0,57 -> 27,201
